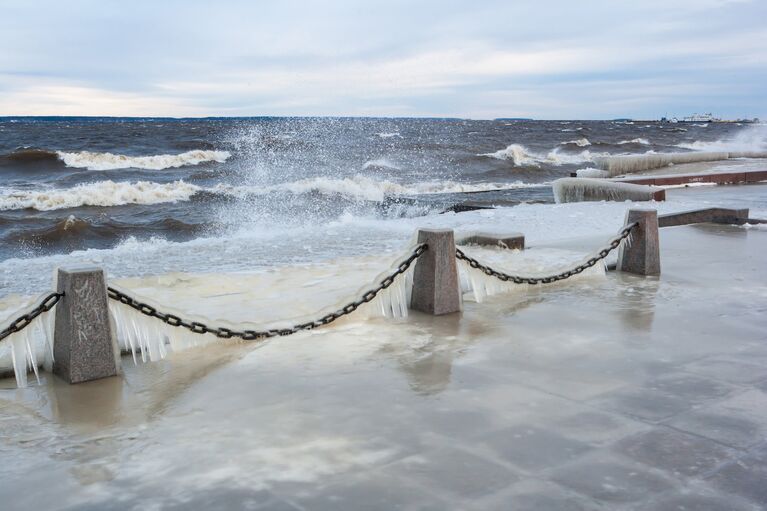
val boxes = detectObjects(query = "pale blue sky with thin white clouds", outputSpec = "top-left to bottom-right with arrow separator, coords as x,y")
0,0 -> 767,119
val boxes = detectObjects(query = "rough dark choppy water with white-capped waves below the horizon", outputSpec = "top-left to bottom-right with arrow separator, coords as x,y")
0,118 -> 764,294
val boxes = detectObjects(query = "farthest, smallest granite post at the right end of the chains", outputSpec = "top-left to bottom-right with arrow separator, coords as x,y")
616,209 -> 660,275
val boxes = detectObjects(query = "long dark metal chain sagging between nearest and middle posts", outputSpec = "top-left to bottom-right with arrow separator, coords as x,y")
107,243 -> 428,341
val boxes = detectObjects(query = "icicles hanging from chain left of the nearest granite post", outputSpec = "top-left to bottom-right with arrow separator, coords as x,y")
0,293 -> 55,388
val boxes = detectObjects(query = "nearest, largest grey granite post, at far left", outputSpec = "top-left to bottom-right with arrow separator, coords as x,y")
53,267 -> 120,383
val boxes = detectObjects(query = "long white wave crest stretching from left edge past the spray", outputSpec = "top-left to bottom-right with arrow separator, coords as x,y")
0,175 -> 536,211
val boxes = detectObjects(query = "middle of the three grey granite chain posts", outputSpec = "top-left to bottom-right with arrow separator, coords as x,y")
410,229 -> 461,316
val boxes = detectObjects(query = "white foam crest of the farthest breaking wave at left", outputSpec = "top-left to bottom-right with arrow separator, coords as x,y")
56,150 -> 231,170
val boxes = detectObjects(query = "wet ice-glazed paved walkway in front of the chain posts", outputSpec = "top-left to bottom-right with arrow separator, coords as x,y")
0,225 -> 767,511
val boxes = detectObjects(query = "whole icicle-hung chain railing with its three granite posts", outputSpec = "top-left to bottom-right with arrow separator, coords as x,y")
0,210 -> 660,387
